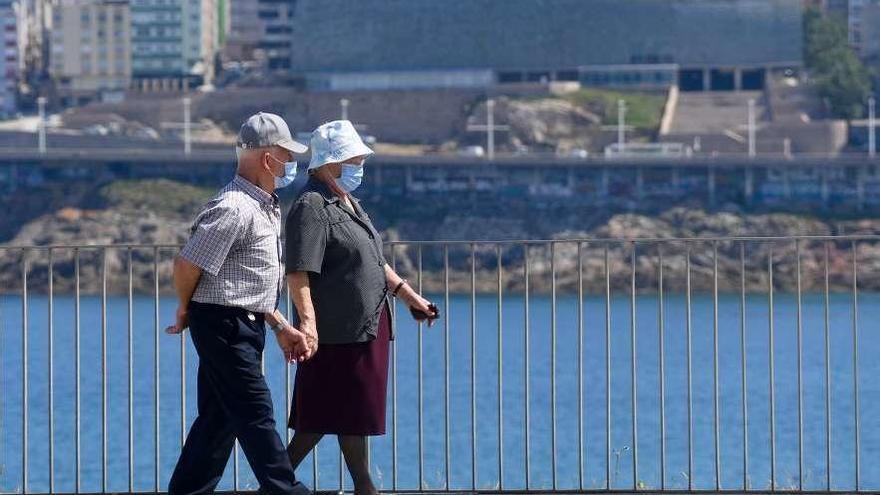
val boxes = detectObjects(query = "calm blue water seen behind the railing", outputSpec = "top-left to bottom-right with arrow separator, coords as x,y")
0,294 -> 880,492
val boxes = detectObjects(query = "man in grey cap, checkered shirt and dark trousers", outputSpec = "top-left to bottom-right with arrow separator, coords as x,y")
166,113 -> 311,495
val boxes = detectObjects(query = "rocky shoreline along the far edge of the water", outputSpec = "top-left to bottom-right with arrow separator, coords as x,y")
0,208 -> 880,294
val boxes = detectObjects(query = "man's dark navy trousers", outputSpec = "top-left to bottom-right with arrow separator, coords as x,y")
168,302 -> 311,495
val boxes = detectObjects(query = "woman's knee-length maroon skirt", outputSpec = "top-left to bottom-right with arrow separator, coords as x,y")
287,305 -> 391,436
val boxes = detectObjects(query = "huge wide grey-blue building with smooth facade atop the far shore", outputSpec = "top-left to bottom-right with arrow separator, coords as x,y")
290,0 -> 804,90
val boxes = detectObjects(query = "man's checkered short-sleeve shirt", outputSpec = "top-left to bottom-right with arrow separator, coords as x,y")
180,175 -> 284,313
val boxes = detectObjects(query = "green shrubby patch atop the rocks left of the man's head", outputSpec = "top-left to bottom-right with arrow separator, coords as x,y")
100,179 -> 215,216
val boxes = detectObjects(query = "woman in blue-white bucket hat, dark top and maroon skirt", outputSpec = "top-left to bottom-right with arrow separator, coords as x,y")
286,120 -> 437,495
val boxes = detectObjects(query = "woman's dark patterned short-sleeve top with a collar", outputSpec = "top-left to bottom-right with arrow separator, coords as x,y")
285,178 -> 388,344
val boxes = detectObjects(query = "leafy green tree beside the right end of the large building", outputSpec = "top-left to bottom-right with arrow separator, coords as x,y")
804,9 -> 871,120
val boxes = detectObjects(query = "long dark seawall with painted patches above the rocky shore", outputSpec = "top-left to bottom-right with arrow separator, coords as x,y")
0,153 -> 880,213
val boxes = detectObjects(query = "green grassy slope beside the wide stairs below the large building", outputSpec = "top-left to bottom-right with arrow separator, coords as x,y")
563,88 -> 666,131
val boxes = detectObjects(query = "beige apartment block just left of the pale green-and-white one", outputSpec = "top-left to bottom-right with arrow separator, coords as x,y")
49,0 -> 132,105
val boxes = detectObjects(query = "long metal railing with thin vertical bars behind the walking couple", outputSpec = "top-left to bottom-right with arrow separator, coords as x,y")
0,236 -> 880,493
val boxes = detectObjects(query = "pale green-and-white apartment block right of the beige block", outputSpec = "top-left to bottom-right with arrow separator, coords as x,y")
131,0 -> 220,91
